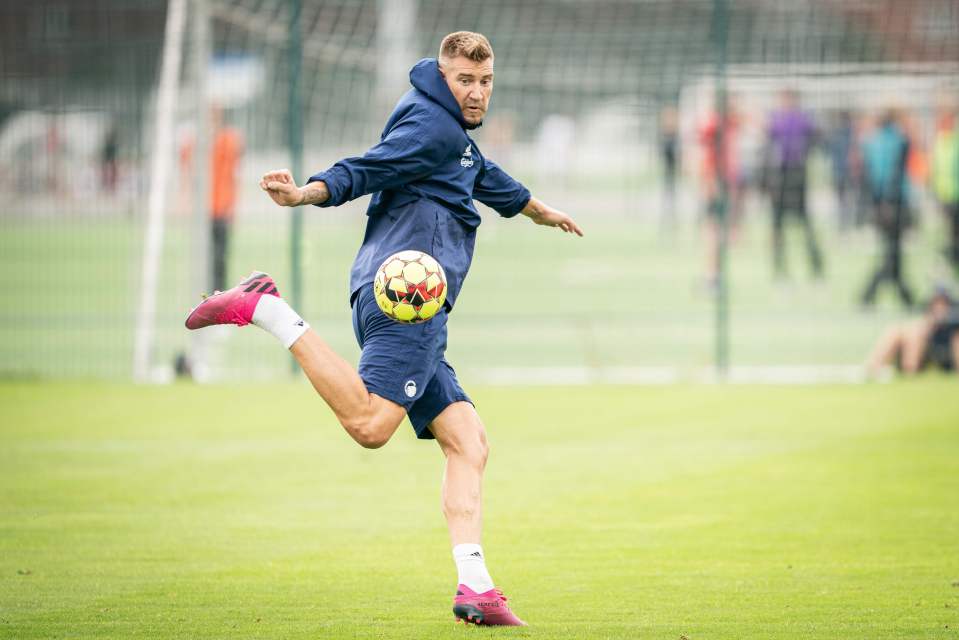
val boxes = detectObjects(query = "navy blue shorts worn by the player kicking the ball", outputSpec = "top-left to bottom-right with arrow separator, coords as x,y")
353,283 -> 473,439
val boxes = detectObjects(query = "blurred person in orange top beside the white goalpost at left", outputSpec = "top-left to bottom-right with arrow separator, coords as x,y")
210,108 -> 243,291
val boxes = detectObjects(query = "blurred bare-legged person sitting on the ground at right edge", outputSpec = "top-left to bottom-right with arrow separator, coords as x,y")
866,288 -> 959,377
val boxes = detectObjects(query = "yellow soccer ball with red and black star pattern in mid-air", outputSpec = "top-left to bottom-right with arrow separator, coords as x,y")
373,251 -> 446,324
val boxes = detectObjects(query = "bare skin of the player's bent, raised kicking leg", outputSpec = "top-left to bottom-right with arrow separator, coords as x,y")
290,329 -> 406,449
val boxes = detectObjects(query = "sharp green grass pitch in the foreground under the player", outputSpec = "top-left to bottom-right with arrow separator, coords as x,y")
0,378 -> 959,640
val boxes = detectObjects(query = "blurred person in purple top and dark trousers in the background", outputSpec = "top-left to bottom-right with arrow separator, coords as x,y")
765,89 -> 823,278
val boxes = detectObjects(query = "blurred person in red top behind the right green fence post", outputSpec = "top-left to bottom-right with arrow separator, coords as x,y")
698,96 -> 742,292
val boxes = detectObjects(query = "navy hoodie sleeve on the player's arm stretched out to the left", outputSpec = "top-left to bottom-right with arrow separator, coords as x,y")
307,117 -> 449,207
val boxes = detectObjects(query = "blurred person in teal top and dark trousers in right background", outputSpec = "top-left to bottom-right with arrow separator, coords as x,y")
862,109 -> 913,308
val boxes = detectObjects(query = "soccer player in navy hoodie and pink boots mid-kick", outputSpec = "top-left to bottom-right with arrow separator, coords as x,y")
186,31 -> 583,625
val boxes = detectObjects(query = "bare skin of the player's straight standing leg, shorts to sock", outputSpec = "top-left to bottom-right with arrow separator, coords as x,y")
430,402 -> 489,547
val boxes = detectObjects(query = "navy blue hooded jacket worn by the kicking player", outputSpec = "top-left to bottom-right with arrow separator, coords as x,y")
309,58 -> 530,309
